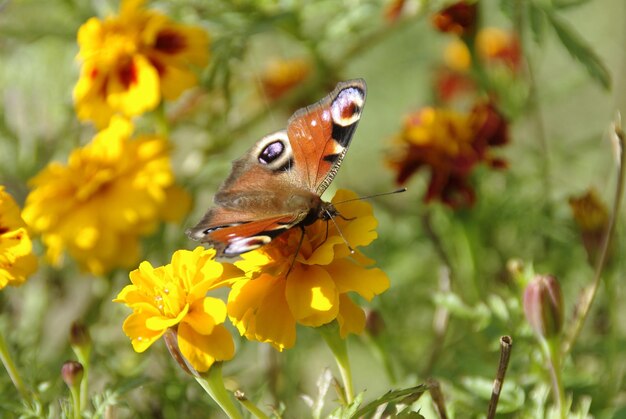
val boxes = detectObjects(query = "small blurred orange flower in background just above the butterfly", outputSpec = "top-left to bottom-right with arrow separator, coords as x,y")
261,58 -> 311,100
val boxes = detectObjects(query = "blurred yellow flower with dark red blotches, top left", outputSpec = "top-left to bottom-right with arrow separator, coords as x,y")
74,0 -> 209,127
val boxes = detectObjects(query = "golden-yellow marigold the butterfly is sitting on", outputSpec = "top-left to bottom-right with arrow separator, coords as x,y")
228,191 -> 389,351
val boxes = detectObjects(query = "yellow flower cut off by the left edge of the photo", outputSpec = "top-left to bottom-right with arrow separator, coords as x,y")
0,185 -> 37,289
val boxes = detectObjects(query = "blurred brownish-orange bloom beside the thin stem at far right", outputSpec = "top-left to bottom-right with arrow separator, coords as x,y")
569,189 -> 611,264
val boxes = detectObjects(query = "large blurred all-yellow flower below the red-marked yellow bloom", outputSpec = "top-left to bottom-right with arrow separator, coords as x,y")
23,117 -> 189,274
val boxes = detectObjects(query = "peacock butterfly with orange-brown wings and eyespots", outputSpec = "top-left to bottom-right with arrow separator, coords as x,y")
187,79 -> 367,257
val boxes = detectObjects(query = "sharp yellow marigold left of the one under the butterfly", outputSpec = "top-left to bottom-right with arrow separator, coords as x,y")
113,247 -> 238,372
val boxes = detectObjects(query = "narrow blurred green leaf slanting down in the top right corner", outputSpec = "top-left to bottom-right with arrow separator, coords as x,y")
544,9 -> 611,90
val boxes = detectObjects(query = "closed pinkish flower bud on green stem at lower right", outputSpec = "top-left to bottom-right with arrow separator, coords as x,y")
524,275 -> 563,338
